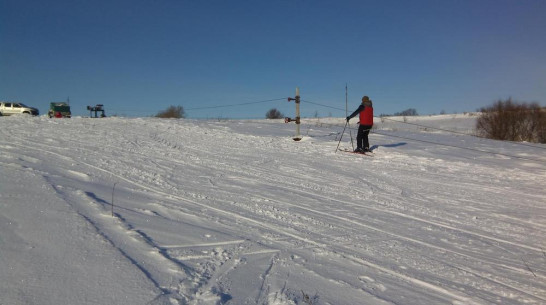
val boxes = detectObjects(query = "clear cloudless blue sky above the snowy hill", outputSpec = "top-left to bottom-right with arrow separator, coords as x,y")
0,0 -> 546,118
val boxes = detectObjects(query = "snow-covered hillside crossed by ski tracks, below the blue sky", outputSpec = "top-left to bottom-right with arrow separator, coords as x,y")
0,115 -> 546,305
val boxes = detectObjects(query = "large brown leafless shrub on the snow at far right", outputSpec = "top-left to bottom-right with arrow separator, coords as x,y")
476,98 -> 546,143
